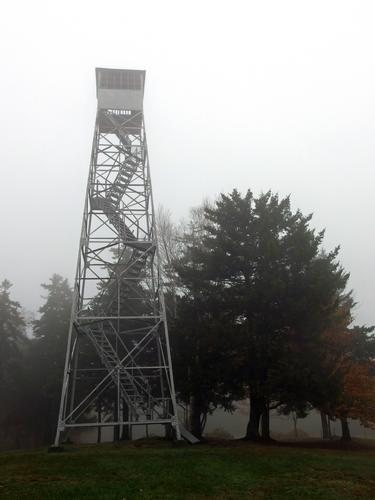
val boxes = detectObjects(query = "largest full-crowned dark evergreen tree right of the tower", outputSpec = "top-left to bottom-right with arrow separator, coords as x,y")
177,190 -> 348,439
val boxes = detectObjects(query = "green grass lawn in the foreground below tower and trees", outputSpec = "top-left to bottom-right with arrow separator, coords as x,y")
0,441 -> 375,500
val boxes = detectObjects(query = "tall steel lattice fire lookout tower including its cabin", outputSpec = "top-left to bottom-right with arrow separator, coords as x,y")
55,68 -> 187,445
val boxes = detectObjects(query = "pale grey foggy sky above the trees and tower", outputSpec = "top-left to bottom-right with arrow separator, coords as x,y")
0,0 -> 375,324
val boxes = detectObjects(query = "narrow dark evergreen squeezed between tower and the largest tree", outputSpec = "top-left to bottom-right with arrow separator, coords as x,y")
171,212 -> 244,437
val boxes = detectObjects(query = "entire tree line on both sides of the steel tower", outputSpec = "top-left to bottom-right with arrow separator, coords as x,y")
0,190 -> 375,447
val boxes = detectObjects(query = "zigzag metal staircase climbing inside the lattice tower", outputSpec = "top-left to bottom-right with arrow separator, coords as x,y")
83,112 -> 199,444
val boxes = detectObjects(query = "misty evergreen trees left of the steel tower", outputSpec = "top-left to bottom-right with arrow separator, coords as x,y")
0,274 -> 72,449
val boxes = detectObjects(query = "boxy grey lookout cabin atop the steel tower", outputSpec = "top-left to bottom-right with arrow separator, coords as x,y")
96,68 -> 146,111
